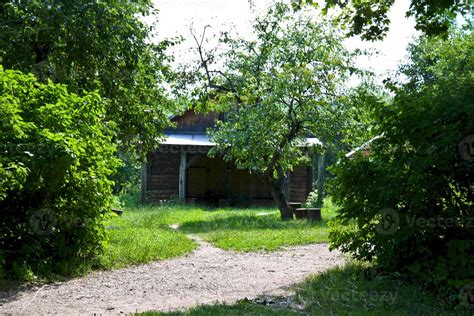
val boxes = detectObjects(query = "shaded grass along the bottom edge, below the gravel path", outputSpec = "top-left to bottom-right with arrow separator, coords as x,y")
144,263 -> 462,316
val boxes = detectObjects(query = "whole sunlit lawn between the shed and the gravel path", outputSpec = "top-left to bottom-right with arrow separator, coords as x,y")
98,200 -> 336,269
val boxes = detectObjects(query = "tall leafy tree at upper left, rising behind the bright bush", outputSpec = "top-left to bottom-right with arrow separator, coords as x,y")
0,0 -> 172,154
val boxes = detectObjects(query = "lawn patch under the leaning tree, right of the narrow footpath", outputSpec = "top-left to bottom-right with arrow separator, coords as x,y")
180,204 -> 334,251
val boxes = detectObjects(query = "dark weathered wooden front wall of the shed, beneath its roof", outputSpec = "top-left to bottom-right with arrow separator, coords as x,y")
146,146 -> 311,205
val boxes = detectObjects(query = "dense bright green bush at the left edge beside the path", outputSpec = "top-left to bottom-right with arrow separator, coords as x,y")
0,66 -> 118,277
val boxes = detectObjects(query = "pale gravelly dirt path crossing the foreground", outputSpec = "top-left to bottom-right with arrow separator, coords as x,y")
0,237 -> 343,315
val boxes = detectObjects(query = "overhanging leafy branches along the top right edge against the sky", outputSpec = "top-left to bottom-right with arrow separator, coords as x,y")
293,0 -> 473,40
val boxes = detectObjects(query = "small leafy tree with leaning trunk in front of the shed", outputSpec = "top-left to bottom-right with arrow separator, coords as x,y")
186,3 -> 362,219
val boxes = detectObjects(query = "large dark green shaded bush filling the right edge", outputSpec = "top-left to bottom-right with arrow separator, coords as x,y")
330,33 -> 474,300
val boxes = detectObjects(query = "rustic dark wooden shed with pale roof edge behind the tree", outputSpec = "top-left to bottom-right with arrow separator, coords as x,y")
142,110 -> 314,205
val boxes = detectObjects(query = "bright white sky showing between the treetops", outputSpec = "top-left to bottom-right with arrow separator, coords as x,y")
150,0 -> 416,78
